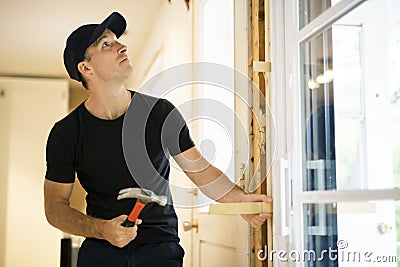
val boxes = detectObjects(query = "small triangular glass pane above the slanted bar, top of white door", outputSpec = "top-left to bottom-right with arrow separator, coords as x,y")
299,0 -> 340,30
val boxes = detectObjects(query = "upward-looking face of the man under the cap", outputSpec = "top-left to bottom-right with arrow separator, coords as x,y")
85,30 -> 133,82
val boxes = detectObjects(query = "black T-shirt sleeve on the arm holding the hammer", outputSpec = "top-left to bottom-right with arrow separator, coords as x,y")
46,124 -> 75,183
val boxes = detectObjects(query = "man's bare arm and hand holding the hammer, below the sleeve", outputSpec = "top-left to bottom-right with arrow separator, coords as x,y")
44,179 -> 140,247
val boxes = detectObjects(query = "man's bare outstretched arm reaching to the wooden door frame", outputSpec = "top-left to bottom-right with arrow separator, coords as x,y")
174,147 -> 272,227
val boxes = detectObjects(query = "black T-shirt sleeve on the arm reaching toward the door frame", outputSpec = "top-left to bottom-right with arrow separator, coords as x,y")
161,99 -> 195,156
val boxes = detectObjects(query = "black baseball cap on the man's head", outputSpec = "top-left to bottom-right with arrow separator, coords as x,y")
64,12 -> 126,82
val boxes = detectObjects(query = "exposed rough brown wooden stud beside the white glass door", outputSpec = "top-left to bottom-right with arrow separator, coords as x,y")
251,0 -> 274,267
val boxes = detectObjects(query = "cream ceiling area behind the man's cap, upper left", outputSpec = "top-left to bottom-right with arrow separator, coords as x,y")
0,0 -> 164,77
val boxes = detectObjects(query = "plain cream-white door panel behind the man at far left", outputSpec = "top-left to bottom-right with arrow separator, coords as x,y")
0,77 -> 68,267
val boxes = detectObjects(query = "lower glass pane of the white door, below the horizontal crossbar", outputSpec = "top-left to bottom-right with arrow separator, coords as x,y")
302,201 -> 400,267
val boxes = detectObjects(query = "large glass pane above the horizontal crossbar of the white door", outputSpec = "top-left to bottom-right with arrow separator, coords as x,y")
300,0 -> 400,191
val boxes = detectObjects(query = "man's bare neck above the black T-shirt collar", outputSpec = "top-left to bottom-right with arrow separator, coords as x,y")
85,85 -> 131,120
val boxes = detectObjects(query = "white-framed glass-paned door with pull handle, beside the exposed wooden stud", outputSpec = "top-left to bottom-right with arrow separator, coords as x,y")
275,0 -> 400,266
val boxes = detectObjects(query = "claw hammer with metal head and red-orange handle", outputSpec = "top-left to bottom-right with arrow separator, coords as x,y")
117,188 -> 167,227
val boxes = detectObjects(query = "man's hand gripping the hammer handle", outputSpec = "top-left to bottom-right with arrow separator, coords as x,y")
101,215 -> 142,248
